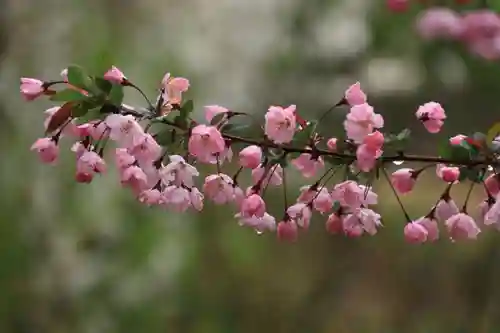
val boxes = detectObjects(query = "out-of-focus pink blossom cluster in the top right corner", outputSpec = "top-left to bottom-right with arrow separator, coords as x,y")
387,0 -> 500,61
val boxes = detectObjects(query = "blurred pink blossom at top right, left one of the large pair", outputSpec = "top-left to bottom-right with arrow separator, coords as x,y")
417,7 -> 464,40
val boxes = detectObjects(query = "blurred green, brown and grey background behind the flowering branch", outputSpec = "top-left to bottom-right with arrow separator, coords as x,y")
0,0 -> 500,333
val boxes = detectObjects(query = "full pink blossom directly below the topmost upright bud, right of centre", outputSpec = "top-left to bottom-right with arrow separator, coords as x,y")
344,103 -> 384,143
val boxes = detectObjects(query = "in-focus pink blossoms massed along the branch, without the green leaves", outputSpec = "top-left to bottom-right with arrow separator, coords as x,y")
21,67 -> 500,243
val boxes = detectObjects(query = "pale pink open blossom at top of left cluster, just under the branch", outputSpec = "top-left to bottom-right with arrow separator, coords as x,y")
104,114 -> 144,148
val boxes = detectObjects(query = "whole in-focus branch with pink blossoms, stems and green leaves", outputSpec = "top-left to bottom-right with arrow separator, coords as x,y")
20,66 -> 500,243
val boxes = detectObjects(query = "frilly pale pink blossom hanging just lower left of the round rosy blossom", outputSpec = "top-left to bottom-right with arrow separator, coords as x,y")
159,155 -> 200,187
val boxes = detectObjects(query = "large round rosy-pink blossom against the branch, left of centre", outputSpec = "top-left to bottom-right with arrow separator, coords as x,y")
188,125 -> 226,161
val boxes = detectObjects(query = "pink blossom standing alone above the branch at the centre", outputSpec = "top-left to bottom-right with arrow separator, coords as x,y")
265,105 -> 297,144
